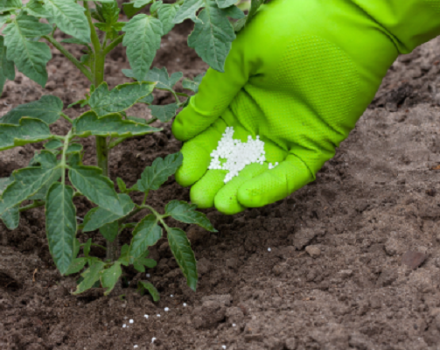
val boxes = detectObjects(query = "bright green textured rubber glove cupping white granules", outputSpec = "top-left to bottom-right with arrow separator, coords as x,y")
173,0 -> 440,214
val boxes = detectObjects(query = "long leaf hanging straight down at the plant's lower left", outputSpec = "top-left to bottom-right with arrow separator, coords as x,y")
46,182 -> 76,275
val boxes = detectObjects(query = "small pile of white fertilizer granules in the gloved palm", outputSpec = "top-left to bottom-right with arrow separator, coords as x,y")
208,127 -> 278,183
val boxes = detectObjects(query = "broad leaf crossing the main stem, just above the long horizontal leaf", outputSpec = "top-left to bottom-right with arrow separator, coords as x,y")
89,82 -> 154,116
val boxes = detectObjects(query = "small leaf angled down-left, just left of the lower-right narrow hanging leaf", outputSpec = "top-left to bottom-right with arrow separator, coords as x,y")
130,214 -> 162,259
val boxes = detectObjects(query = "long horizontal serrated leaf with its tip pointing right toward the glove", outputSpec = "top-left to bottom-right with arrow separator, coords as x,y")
74,111 -> 161,137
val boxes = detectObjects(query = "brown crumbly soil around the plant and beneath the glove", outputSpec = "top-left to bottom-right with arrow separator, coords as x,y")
0,19 -> 440,350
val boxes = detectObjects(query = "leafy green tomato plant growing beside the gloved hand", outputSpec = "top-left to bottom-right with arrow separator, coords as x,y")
0,0 -> 261,300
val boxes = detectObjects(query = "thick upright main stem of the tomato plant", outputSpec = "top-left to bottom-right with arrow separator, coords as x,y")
83,1 -> 119,262
